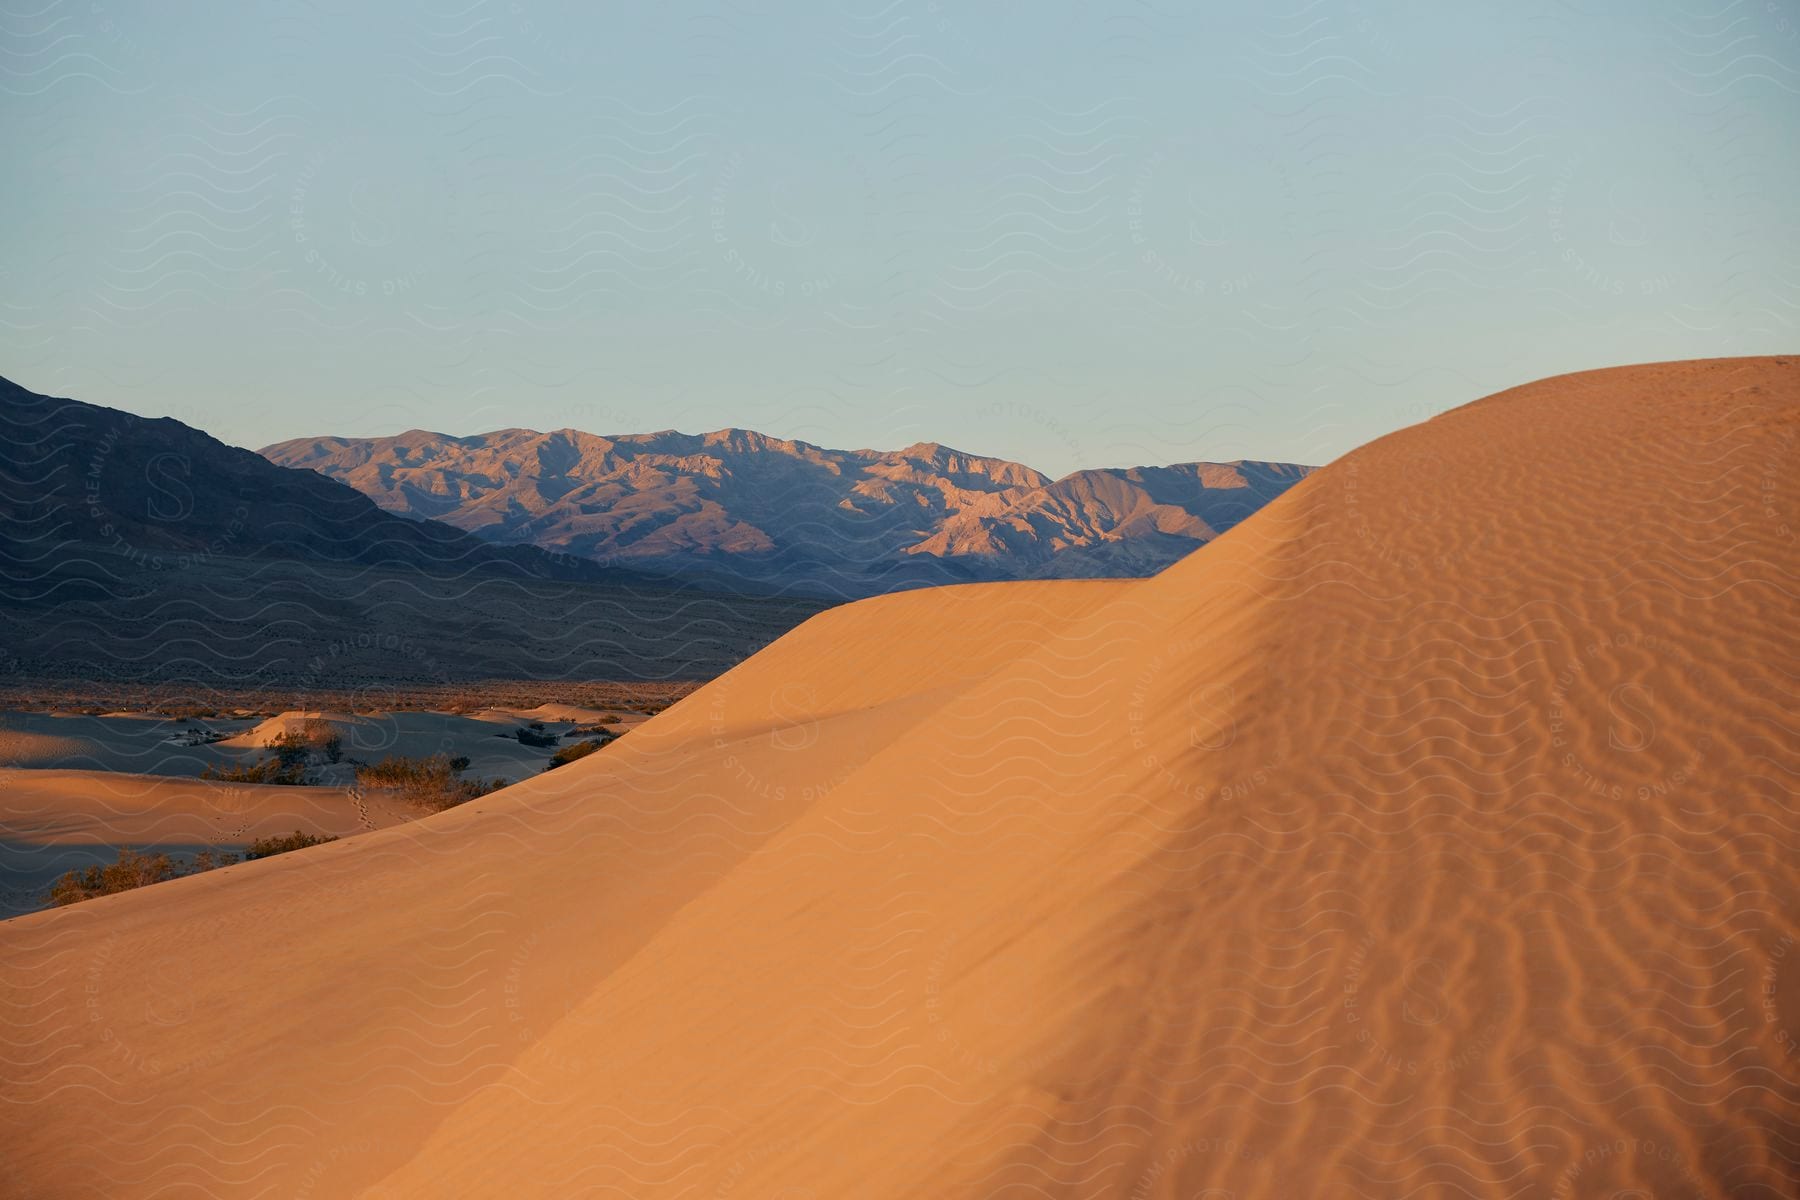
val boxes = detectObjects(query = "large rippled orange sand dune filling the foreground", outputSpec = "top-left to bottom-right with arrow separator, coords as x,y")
0,358 -> 1800,1198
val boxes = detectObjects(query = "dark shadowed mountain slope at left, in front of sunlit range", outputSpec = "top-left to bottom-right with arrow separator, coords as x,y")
0,380 -> 823,691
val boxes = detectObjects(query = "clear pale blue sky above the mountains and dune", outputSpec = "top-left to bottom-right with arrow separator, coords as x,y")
0,0 -> 1800,473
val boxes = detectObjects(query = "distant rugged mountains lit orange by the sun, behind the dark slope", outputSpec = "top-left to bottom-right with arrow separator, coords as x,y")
261,428 -> 1310,597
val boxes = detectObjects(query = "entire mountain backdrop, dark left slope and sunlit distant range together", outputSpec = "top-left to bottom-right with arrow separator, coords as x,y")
0,380 -> 1307,691
